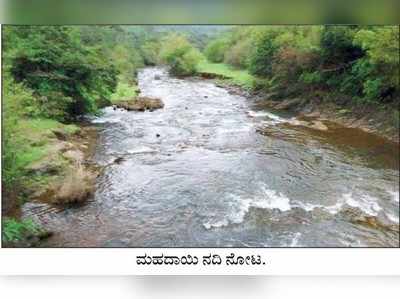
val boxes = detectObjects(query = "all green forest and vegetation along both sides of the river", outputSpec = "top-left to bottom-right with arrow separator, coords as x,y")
2,26 -> 400,246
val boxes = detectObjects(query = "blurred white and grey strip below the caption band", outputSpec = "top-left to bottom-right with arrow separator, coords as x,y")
0,276 -> 400,299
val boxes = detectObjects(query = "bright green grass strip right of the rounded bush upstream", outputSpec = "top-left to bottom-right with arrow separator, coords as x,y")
197,60 -> 255,89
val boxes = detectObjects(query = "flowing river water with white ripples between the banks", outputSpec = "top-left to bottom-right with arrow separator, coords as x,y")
25,67 -> 399,247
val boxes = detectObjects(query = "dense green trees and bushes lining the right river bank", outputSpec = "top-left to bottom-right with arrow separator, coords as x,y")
205,26 -> 399,104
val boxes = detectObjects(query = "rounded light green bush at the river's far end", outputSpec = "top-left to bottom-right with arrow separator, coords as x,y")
161,34 -> 201,76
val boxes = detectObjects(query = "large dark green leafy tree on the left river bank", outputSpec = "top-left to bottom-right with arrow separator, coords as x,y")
4,26 -> 117,120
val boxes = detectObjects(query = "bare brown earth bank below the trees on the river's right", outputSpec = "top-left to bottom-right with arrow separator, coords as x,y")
198,72 -> 400,144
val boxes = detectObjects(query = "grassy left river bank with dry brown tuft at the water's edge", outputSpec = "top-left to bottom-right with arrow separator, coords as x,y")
2,120 -> 100,247
